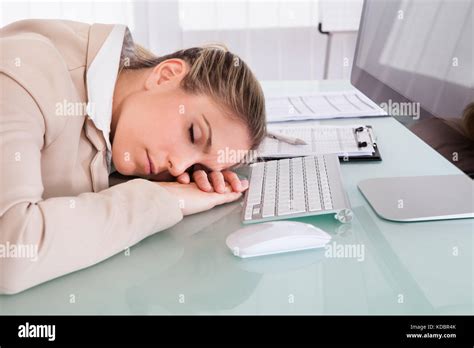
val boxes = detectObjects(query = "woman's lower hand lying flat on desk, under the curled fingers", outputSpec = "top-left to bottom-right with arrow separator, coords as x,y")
156,182 -> 242,215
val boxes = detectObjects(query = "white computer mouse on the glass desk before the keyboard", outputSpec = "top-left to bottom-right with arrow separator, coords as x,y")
226,221 -> 331,258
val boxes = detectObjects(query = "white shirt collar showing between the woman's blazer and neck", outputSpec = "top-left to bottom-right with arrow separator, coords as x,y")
86,24 -> 133,174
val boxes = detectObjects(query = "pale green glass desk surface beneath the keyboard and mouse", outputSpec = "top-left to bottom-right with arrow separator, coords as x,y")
0,81 -> 474,314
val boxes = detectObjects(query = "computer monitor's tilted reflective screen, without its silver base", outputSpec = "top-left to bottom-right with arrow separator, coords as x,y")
351,0 -> 474,176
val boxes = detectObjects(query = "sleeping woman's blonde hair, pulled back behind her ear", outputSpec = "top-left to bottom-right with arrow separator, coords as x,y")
124,44 -> 266,149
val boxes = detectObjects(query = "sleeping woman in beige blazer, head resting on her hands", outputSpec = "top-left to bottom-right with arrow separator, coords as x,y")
0,20 -> 266,294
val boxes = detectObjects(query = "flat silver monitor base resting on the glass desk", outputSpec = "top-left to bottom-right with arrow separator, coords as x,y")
358,174 -> 474,222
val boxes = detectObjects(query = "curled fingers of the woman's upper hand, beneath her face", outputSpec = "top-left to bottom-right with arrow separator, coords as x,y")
176,169 -> 249,193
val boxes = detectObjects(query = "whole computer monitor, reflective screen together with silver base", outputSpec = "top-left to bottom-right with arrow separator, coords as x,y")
351,0 -> 474,222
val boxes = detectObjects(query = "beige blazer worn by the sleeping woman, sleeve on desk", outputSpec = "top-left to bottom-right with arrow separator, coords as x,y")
0,20 -> 183,294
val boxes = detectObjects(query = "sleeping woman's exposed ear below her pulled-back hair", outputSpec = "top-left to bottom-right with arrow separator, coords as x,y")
145,58 -> 187,90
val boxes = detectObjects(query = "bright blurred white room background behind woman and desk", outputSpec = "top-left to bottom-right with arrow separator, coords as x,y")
0,0 -> 363,80
